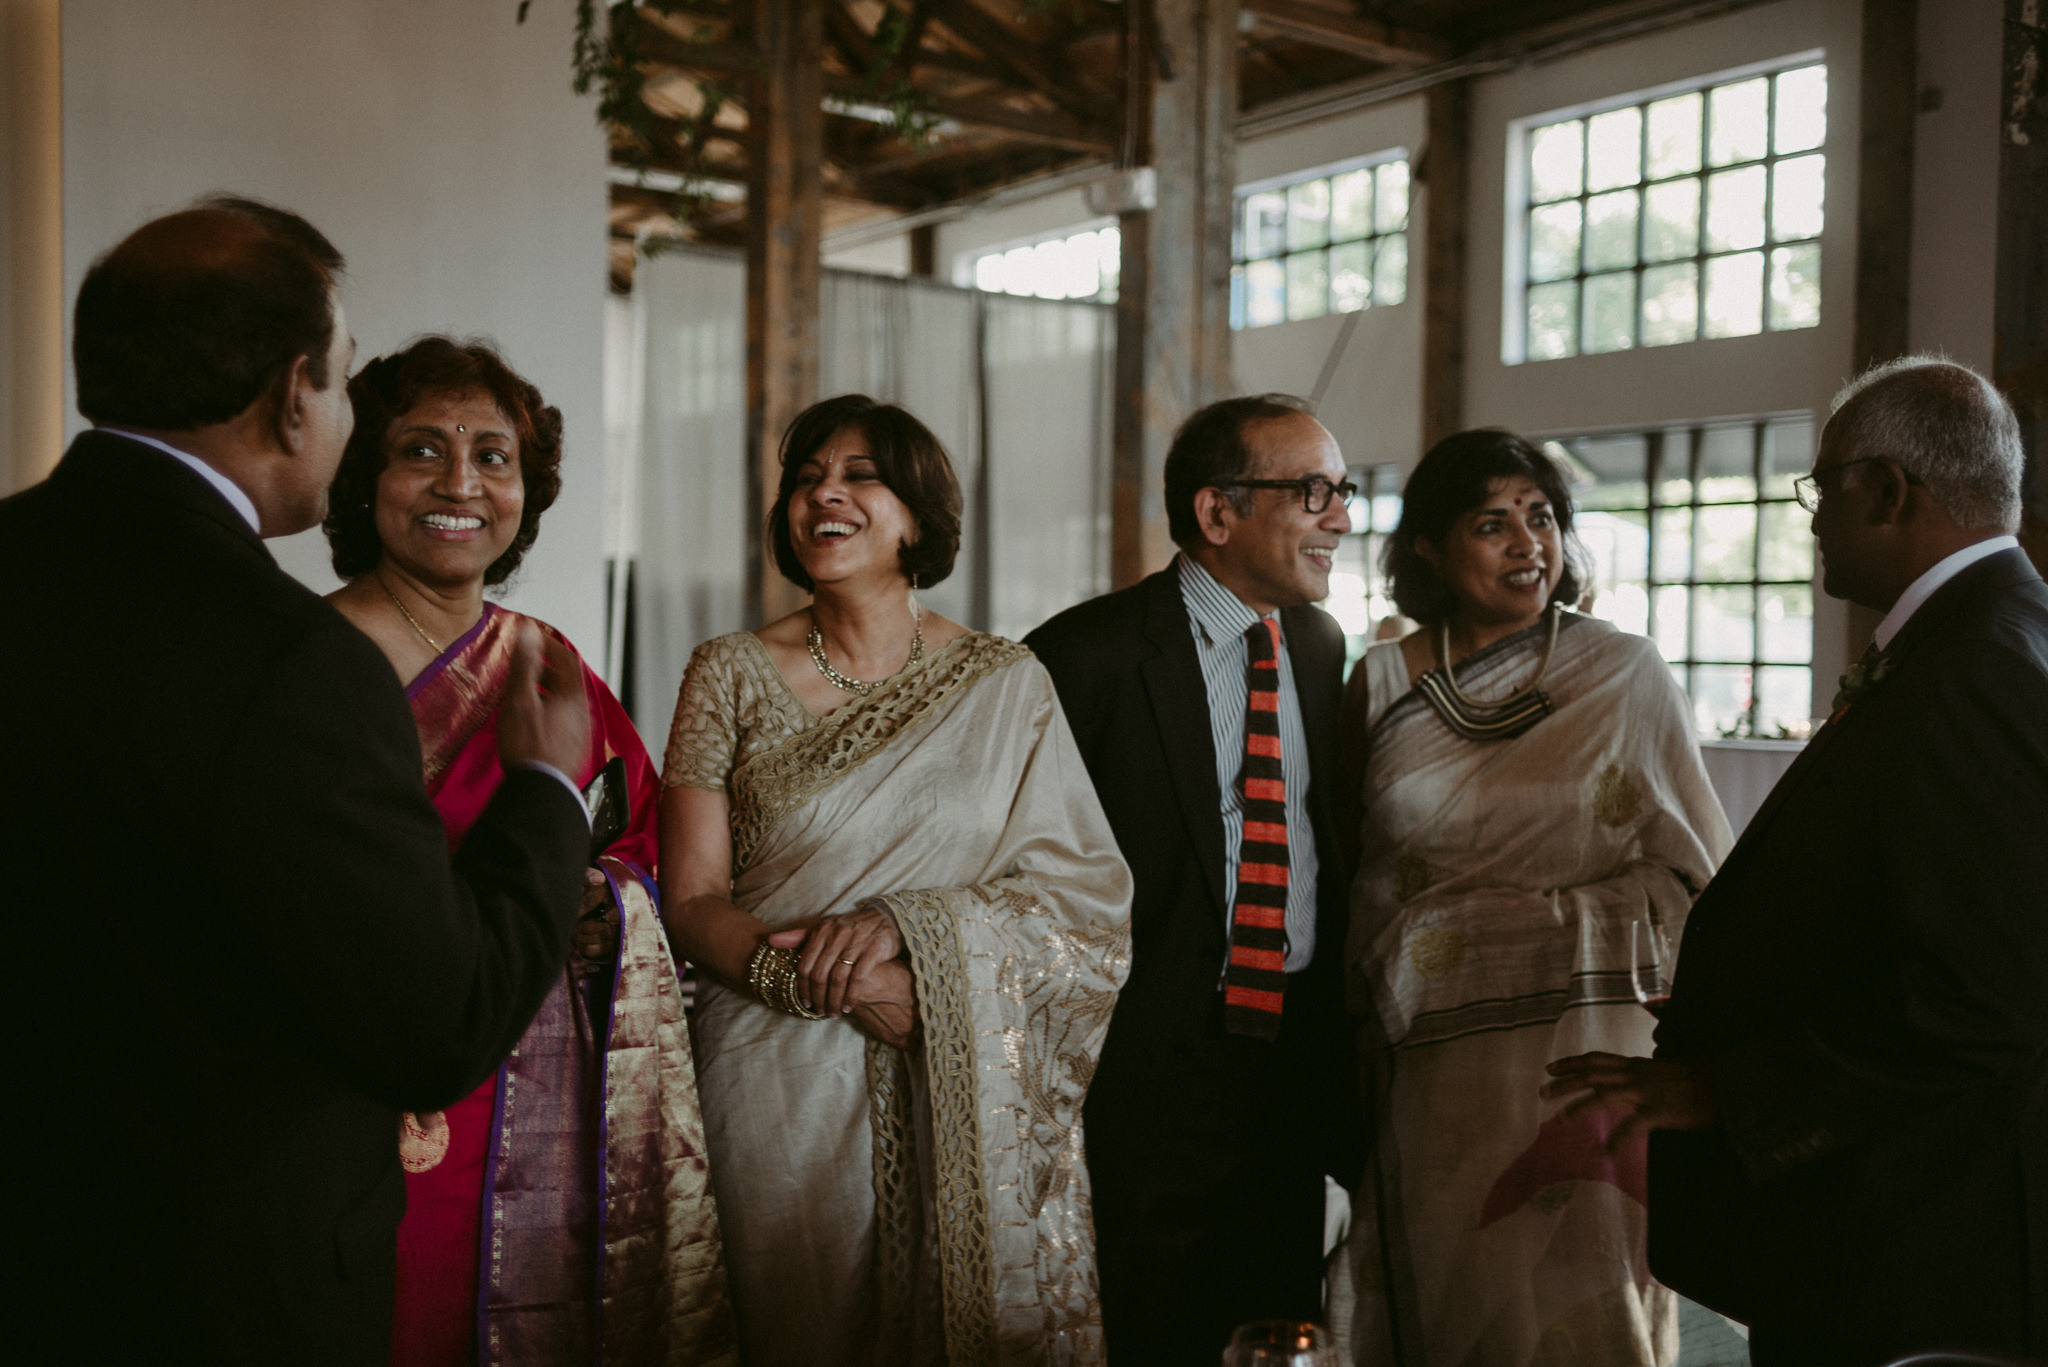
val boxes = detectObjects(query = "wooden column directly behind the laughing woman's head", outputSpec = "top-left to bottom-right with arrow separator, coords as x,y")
748,0 -> 825,623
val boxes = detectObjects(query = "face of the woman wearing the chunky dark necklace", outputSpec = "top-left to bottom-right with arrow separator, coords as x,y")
1415,475 -> 1565,629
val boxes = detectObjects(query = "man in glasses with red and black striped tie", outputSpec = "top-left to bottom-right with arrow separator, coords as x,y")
1026,398 -> 1354,1367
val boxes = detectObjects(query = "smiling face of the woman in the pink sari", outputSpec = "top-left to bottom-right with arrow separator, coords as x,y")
377,389 -> 526,588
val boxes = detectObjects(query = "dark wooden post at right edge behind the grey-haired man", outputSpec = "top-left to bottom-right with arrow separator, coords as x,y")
1991,0 -> 2048,564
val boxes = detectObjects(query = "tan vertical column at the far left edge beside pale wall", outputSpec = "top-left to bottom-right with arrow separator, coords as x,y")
0,0 -> 63,498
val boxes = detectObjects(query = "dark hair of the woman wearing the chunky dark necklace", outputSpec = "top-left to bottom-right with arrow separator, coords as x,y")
1380,426 -> 1585,625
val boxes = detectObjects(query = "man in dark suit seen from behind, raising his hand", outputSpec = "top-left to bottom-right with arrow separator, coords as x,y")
0,199 -> 590,1365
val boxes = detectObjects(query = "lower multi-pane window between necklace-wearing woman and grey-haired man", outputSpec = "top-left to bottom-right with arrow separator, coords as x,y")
1550,414 -> 1815,738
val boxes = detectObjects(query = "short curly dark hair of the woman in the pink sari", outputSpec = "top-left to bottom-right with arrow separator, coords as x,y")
319,336 -> 561,584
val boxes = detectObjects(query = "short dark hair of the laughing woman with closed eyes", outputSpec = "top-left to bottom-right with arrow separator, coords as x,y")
768,393 -> 961,592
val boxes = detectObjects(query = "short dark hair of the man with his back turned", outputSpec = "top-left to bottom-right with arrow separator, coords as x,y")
72,195 -> 344,432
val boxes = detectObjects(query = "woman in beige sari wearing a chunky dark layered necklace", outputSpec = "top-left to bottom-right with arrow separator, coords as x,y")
1333,432 -> 1729,1367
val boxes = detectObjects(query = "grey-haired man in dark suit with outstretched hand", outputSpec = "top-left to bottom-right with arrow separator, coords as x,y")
1546,359 -> 2048,1367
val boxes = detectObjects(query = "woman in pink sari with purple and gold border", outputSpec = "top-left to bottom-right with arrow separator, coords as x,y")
326,336 -> 733,1367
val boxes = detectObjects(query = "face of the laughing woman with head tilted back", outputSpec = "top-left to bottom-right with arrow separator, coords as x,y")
788,426 -> 918,584
